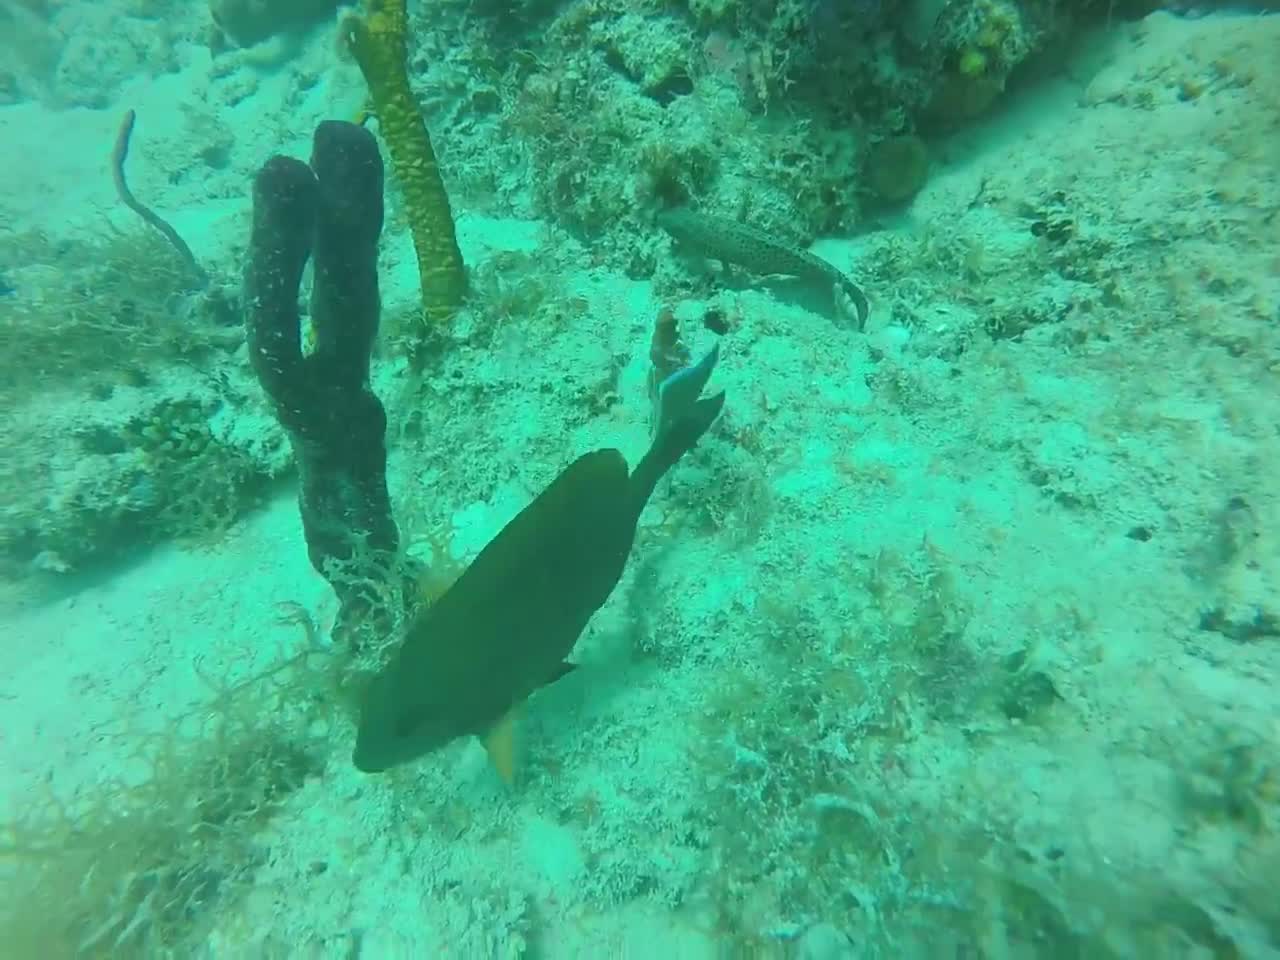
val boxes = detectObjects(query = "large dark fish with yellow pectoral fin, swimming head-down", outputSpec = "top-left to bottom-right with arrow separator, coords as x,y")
352,349 -> 724,782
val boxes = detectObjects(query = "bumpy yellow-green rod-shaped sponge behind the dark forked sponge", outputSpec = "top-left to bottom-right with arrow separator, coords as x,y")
343,0 -> 466,324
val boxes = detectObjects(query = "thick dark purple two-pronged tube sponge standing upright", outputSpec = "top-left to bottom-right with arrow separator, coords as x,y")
244,122 -> 399,647
